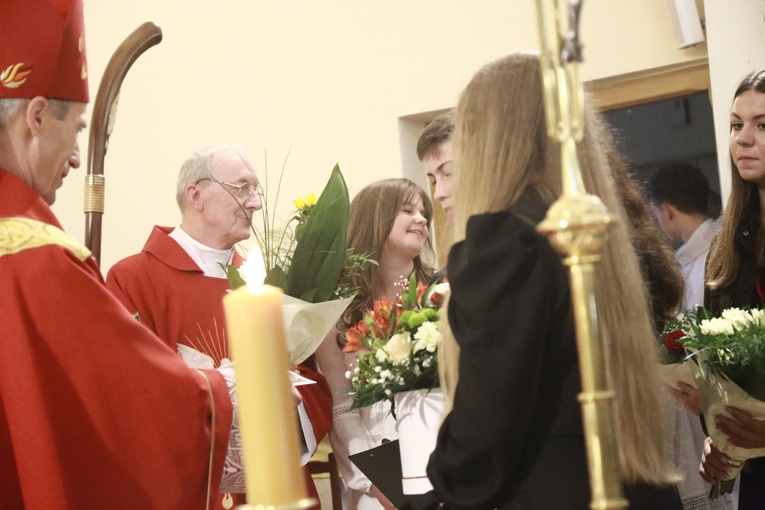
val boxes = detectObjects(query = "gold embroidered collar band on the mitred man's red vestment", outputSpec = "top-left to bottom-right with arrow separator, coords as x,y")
0,218 -> 90,261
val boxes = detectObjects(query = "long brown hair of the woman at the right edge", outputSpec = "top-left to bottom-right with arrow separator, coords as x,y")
704,69 -> 765,290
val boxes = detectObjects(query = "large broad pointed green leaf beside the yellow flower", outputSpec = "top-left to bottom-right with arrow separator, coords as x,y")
286,165 -> 350,302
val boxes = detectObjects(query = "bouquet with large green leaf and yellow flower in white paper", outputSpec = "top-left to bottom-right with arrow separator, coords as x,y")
221,161 -> 372,364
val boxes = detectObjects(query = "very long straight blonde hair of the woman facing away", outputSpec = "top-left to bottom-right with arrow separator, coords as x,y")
442,54 -> 675,483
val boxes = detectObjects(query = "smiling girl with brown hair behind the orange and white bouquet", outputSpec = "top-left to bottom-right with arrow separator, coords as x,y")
317,178 -> 433,510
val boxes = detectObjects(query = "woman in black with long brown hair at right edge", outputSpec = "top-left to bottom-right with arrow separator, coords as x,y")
701,69 -> 765,510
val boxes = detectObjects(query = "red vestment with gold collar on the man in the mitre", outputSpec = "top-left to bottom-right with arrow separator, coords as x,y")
0,169 -> 232,510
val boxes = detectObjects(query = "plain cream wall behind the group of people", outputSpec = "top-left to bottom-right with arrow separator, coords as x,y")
54,0 -> 706,269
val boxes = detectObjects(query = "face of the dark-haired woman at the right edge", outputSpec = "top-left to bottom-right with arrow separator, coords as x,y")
730,90 -> 765,189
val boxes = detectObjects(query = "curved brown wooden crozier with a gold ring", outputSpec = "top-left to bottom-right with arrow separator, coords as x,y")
85,21 -> 162,263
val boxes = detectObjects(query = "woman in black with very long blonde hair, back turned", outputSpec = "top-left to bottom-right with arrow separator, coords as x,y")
417,54 -> 682,510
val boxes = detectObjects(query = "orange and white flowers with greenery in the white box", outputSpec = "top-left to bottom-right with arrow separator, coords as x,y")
343,274 -> 449,417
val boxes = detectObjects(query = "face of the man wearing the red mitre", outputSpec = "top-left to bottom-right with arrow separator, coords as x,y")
20,98 -> 87,204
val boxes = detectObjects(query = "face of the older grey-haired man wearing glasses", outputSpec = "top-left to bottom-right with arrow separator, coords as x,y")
197,152 -> 261,249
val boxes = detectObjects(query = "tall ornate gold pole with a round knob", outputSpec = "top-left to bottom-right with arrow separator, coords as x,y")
537,0 -> 627,510
